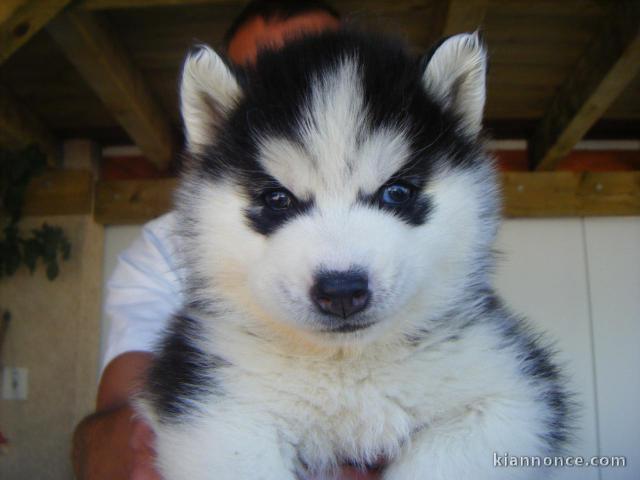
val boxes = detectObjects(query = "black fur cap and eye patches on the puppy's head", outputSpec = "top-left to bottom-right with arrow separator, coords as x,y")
192,30 -> 477,235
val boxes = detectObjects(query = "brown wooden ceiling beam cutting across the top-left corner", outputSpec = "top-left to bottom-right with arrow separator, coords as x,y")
0,0 -> 71,65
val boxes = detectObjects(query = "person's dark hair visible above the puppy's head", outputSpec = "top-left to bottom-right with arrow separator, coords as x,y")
224,0 -> 340,47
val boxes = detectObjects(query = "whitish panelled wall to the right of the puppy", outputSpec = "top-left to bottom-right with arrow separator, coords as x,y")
496,217 -> 640,480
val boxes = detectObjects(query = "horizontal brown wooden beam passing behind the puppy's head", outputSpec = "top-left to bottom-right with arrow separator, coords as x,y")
81,172 -> 640,224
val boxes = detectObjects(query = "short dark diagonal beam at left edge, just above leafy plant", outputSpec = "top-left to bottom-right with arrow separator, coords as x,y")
0,85 -> 61,165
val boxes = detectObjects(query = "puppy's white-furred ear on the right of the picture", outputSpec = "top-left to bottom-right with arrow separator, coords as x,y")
422,32 -> 487,137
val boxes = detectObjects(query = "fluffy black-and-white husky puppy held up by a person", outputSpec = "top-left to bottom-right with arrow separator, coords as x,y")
139,30 -> 571,480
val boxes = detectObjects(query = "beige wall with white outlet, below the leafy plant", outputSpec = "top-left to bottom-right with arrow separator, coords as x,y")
0,216 -> 104,480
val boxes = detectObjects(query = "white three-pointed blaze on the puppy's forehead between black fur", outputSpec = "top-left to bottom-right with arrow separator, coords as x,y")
258,55 -> 410,200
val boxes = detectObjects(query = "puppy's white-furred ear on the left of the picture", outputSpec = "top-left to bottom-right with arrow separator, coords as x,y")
180,45 -> 242,153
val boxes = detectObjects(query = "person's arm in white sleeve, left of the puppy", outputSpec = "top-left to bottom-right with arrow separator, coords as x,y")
73,214 -> 182,480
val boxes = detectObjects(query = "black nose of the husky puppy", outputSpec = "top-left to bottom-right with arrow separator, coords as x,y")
311,271 -> 371,318
